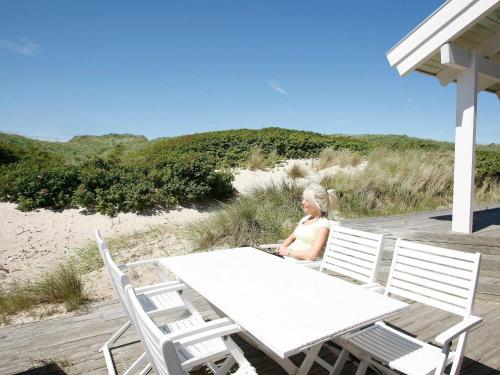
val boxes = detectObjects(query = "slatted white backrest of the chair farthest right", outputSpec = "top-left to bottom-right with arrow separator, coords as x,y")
385,240 -> 481,316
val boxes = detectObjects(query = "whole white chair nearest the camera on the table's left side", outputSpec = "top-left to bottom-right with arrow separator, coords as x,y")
125,285 -> 257,375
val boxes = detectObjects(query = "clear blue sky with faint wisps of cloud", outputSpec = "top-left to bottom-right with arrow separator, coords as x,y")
0,0 -> 500,143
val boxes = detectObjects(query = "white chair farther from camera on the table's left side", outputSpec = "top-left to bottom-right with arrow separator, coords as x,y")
95,229 -> 201,375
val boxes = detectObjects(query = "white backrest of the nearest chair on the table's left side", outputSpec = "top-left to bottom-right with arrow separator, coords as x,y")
125,285 -> 184,375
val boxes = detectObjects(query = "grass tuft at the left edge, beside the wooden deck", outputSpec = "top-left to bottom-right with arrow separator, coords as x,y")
0,262 -> 88,323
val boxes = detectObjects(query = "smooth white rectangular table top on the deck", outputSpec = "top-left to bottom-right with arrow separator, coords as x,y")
160,247 -> 407,358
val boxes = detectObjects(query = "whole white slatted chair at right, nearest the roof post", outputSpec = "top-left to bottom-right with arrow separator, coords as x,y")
331,240 -> 482,375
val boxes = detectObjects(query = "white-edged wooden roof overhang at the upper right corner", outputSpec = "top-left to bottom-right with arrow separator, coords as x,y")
387,0 -> 500,98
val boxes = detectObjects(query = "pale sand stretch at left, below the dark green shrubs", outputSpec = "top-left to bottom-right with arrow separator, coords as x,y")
0,206 -> 208,284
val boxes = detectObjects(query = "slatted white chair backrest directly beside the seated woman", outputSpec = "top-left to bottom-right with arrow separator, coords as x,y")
320,225 -> 384,283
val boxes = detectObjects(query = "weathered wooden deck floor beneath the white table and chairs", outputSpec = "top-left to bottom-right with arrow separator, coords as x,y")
0,293 -> 500,375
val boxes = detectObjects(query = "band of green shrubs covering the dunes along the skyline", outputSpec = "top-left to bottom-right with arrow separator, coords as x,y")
0,128 -> 500,215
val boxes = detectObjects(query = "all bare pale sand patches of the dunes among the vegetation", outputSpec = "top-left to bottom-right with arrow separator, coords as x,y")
0,159 -> 366,284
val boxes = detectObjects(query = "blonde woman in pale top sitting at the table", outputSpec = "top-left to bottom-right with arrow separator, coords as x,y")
278,184 -> 333,260
